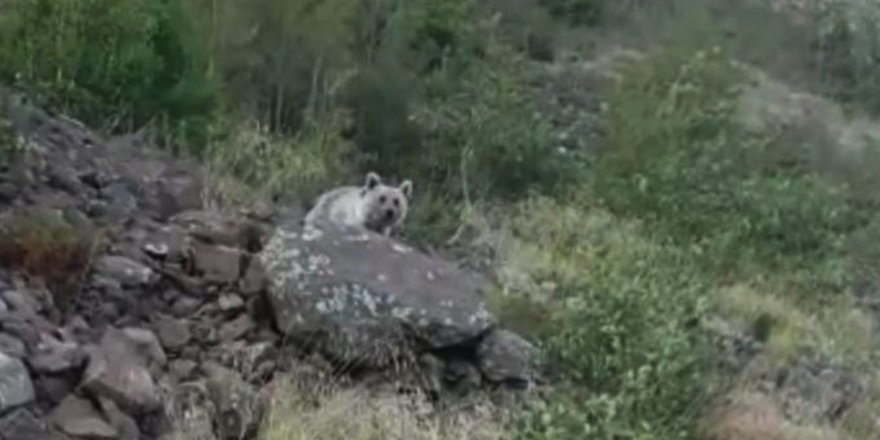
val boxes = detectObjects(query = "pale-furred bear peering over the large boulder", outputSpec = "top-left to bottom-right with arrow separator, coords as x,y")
305,171 -> 413,237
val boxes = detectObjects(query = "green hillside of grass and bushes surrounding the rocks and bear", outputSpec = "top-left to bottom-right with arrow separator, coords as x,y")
0,0 -> 880,440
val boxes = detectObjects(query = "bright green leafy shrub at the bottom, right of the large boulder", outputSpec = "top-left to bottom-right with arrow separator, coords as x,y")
508,207 -> 712,440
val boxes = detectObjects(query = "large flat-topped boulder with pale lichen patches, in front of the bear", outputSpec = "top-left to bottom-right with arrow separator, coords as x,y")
259,221 -> 495,367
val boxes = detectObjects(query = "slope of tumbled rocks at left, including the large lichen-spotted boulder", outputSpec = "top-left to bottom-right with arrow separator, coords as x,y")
0,101 -> 533,440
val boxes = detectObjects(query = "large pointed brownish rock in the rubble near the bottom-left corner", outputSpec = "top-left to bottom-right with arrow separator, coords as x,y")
82,327 -> 160,413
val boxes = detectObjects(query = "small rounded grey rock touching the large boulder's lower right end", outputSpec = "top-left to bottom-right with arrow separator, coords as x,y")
477,330 -> 536,383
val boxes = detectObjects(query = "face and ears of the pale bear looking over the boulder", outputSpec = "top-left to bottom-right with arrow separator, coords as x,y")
360,172 -> 412,231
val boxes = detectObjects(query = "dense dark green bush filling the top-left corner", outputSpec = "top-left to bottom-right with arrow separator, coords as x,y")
0,0 -> 214,143
